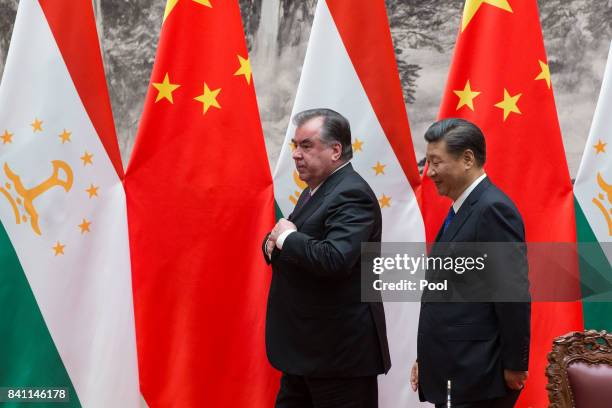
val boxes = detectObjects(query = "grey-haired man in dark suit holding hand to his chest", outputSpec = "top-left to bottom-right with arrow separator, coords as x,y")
263,109 -> 391,408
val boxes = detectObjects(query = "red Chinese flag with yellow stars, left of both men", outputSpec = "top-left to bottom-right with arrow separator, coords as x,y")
125,0 -> 278,408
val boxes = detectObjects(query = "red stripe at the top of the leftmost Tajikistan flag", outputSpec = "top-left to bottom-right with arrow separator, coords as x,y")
39,0 -> 123,179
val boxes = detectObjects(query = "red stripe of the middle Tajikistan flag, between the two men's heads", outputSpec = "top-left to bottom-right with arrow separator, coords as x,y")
322,0 -> 421,202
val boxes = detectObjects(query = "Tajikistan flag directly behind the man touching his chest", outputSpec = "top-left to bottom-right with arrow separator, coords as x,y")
274,0 -> 425,408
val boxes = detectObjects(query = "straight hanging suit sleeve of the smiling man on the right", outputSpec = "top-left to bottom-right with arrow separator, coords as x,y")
477,203 -> 531,371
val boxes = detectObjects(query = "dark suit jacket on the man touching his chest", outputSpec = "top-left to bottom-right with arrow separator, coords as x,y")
263,164 -> 391,377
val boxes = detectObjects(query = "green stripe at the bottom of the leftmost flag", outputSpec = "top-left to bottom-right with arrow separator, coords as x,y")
0,223 -> 81,408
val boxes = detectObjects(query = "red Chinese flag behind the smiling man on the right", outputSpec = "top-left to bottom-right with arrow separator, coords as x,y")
422,0 -> 583,407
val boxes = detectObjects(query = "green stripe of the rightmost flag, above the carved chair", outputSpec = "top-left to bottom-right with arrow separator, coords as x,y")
574,199 -> 612,331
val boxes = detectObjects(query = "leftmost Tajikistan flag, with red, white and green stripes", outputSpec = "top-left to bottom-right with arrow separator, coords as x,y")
0,0 -> 139,408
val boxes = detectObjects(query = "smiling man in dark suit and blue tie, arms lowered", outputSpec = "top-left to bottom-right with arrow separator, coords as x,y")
411,119 -> 531,408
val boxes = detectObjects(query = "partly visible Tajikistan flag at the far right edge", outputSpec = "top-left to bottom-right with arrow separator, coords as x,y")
574,45 -> 612,331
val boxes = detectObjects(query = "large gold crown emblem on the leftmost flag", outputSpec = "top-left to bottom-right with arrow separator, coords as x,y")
0,160 -> 74,235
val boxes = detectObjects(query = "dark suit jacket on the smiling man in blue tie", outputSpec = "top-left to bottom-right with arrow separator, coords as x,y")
417,178 -> 531,404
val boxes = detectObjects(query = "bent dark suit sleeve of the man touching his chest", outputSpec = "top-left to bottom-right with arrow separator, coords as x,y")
279,189 -> 380,278
